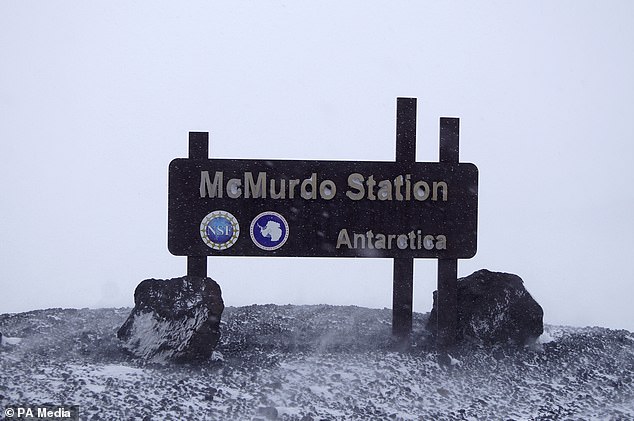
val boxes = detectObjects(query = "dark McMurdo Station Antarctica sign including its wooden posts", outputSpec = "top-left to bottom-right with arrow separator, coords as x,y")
168,98 -> 478,346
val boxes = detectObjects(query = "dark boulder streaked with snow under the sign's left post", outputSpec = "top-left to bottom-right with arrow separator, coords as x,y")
117,276 -> 224,361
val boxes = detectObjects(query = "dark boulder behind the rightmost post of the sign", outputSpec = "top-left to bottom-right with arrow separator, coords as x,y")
427,269 -> 544,345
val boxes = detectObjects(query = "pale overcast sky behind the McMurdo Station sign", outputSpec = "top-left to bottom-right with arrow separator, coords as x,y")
0,0 -> 634,330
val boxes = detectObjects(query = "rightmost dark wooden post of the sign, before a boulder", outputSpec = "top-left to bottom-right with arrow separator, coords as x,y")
436,117 -> 460,350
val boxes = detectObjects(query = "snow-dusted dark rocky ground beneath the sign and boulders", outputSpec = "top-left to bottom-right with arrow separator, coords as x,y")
0,305 -> 634,420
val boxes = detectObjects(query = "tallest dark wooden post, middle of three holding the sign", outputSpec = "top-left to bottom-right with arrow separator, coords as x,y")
392,98 -> 416,339
